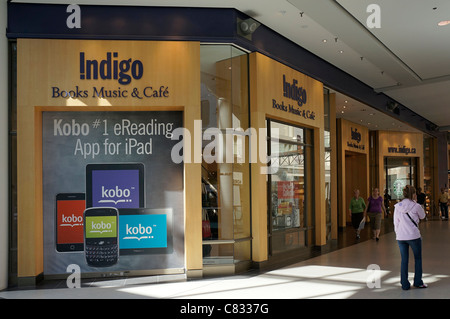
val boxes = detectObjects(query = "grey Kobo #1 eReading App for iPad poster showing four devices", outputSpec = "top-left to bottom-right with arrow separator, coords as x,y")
42,111 -> 185,277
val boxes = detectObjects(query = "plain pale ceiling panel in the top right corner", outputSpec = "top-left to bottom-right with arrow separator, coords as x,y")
337,0 -> 450,80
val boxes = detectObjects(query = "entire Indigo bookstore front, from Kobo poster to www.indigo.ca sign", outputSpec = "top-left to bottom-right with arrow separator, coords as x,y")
8,4 -> 446,285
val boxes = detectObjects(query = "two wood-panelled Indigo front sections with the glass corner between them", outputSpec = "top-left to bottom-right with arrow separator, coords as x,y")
8,35 -> 326,283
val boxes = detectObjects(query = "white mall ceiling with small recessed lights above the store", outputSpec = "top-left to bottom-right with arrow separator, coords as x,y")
13,0 -> 450,130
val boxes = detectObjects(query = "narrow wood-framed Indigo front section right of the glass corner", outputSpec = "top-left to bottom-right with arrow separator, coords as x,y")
250,53 -> 327,265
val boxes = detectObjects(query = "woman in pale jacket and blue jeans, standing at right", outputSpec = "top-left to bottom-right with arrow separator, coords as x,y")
394,185 -> 427,290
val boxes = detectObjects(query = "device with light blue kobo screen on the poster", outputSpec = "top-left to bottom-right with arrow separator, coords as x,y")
119,208 -> 173,255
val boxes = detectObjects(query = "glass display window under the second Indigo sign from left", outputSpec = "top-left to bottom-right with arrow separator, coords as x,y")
268,120 -> 310,255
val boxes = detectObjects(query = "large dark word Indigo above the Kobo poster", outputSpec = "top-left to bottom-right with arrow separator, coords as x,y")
80,52 -> 144,85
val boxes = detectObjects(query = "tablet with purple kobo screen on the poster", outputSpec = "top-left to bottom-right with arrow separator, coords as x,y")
86,163 -> 145,208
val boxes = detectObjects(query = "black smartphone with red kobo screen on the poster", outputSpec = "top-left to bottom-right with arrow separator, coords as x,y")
55,193 -> 86,252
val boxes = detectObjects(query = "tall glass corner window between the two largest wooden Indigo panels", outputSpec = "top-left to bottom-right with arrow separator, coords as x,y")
200,44 -> 251,265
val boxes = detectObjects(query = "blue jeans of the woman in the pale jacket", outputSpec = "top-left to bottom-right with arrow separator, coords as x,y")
397,238 -> 423,290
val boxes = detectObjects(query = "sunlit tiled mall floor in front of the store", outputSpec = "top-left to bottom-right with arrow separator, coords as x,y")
0,221 -> 450,299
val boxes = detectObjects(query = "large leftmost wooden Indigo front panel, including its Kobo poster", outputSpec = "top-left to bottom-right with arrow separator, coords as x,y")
17,39 -> 201,282
